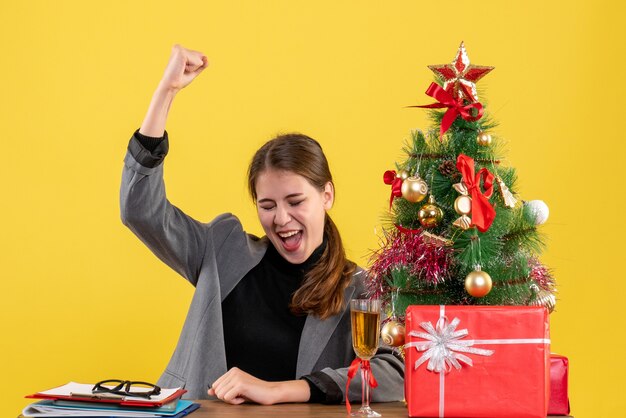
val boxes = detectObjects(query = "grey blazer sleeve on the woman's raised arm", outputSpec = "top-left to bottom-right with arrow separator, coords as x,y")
120,134 -> 228,286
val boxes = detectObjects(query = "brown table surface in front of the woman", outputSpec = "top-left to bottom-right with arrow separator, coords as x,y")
189,400 -> 564,418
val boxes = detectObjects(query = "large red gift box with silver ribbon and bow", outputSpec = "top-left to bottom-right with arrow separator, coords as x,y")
405,306 -> 550,418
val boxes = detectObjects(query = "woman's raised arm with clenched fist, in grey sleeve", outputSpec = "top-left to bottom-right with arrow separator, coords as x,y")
120,45 -> 214,285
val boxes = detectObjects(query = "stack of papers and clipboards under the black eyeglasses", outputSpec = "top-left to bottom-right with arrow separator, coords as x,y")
22,382 -> 200,418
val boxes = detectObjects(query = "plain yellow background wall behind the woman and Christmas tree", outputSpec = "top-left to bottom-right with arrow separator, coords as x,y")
0,0 -> 626,417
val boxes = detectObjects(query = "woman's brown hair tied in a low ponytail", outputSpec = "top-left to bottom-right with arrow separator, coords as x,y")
248,133 -> 356,319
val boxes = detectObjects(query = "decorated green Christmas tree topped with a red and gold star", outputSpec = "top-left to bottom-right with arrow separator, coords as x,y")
370,43 -> 556,346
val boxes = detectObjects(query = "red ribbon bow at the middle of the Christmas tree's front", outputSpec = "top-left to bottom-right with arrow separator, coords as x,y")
456,154 -> 496,232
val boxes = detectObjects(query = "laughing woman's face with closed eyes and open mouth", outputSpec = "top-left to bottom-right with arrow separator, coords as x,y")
256,169 -> 334,264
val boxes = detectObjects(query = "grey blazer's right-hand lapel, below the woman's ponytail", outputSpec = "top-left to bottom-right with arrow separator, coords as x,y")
296,285 -> 354,379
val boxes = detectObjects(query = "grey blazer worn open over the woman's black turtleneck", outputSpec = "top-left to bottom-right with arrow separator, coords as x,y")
120,149 -> 404,402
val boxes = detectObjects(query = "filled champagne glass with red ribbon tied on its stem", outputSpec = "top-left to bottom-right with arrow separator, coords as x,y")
350,299 -> 381,417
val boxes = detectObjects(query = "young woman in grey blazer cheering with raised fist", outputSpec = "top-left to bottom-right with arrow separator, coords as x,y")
120,45 -> 404,404
